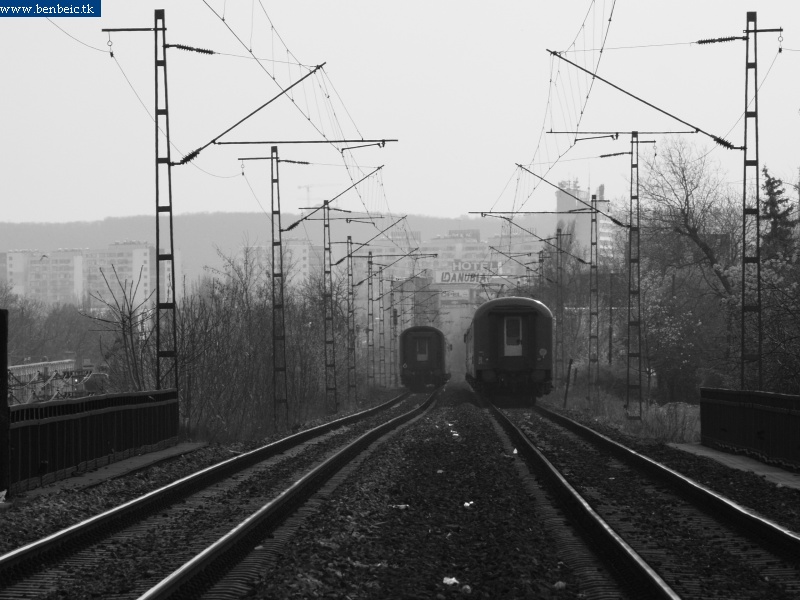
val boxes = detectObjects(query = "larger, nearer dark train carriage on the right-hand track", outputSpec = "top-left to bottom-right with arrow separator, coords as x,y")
464,297 -> 553,403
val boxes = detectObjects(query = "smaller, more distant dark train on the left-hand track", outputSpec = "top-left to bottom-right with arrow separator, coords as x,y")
399,325 -> 450,392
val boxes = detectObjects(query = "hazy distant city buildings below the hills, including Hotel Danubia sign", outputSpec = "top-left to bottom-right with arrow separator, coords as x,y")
0,181 -> 615,310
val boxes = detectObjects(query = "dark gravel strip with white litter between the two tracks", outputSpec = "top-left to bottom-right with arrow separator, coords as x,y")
256,389 -> 580,599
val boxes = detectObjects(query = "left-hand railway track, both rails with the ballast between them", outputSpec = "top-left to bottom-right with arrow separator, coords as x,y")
0,394 -> 433,599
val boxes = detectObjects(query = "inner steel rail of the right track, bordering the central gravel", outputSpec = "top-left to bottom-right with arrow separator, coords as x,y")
486,401 -> 680,600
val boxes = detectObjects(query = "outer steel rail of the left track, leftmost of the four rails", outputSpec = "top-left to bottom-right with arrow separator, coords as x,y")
0,393 -> 409,586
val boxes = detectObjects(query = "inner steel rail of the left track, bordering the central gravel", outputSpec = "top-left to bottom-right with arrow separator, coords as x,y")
139,388 -> 442,600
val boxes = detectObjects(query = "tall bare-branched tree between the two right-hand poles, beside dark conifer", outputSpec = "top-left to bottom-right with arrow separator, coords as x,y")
640,139 -> 741,398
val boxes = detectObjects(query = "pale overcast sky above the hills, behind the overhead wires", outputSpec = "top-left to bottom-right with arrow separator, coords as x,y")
0,0 -> 800,230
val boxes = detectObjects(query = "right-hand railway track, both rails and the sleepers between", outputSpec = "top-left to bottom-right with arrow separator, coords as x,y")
505,408 -> 800,600
